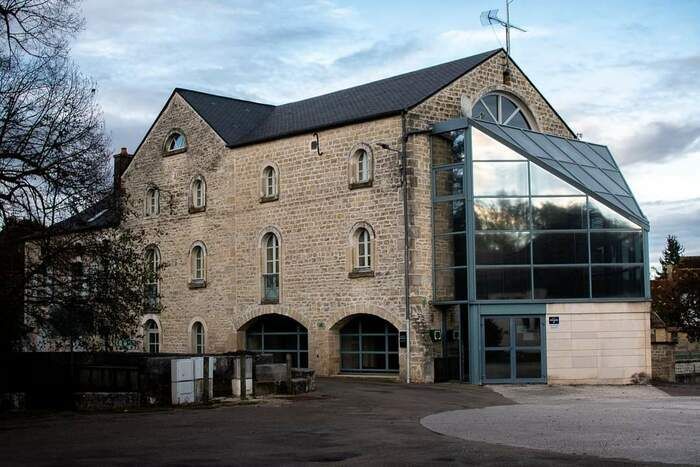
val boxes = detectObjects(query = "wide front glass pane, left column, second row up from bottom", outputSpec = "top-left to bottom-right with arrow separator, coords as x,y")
476,232 -> 530,265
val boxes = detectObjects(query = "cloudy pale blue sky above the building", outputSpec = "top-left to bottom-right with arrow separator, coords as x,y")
72,0 -> 700,264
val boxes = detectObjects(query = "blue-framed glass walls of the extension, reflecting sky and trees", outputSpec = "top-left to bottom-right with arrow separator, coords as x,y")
432,127 -> 644,302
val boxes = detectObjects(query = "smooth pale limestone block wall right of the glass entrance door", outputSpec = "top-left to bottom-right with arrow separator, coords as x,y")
545,302 -> 652,384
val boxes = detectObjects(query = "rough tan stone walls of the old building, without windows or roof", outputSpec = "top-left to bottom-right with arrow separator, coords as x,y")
122,53 -> 644,382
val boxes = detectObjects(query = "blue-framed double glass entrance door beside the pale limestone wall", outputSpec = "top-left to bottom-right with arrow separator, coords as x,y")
481,316 -> 545,383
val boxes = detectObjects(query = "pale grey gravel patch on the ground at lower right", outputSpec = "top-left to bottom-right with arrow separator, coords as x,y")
421,385 -> 700,464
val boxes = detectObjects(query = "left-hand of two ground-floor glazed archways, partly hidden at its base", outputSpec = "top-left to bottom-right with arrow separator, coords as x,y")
245,314 -> 309,368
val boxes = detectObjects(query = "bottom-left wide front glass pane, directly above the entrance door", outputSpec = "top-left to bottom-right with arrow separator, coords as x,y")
476,268 -> 531,300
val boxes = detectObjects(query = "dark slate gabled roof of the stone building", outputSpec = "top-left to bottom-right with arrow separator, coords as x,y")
175,49 -> 502,147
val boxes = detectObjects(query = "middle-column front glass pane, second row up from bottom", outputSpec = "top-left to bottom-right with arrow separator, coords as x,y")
532,233 -> 588,264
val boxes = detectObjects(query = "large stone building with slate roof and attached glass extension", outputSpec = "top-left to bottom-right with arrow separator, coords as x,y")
108,49 -> 651,383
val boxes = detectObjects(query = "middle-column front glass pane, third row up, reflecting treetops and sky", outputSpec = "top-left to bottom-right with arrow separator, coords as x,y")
532,196 -> 586,230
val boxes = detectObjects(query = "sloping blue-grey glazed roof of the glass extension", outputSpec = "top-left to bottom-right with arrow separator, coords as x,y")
469,118 -> 649,229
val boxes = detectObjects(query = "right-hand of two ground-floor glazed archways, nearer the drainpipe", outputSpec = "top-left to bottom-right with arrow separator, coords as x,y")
340,314 -> 399,373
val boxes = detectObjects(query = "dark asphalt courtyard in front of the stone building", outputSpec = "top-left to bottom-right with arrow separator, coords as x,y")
0,378 -> 697,465
